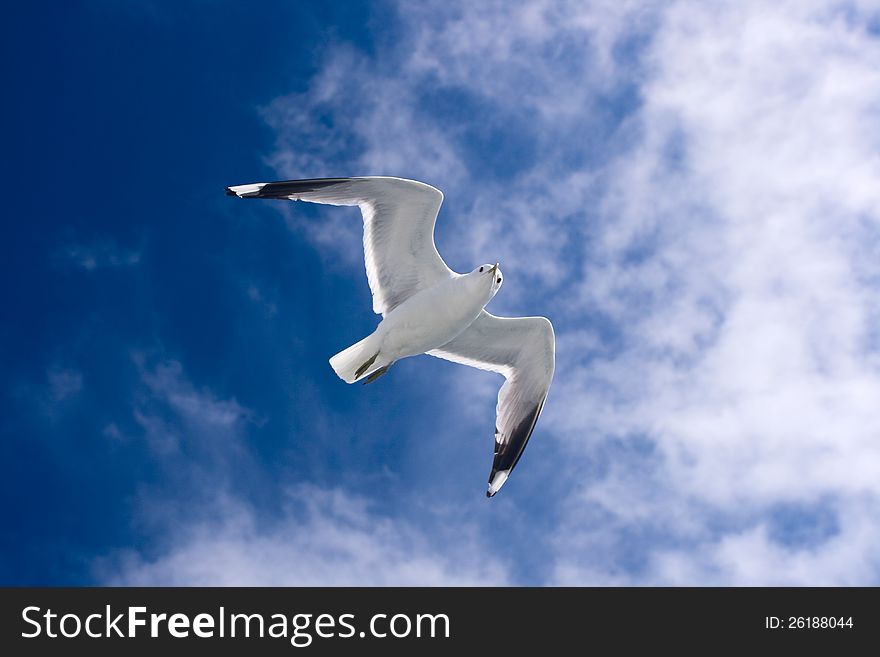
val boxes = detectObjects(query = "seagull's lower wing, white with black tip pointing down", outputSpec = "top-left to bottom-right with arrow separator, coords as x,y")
428,310 -> 556,497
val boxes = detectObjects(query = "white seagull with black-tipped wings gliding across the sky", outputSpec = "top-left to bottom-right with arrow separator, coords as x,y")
226,176 -> 556,497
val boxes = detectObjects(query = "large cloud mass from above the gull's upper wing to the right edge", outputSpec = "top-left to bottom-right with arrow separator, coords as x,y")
258,2 -> 880,584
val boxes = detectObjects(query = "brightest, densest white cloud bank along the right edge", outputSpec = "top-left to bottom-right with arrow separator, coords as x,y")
557,3 -> 880,584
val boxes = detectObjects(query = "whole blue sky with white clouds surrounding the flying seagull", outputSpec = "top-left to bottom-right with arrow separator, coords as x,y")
0,0 -> 880,585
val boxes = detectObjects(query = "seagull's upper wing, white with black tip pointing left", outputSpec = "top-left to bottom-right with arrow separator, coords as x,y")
226,176 -> 453,315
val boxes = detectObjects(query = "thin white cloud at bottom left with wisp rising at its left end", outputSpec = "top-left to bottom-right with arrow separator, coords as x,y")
101,354 -> 510,586
